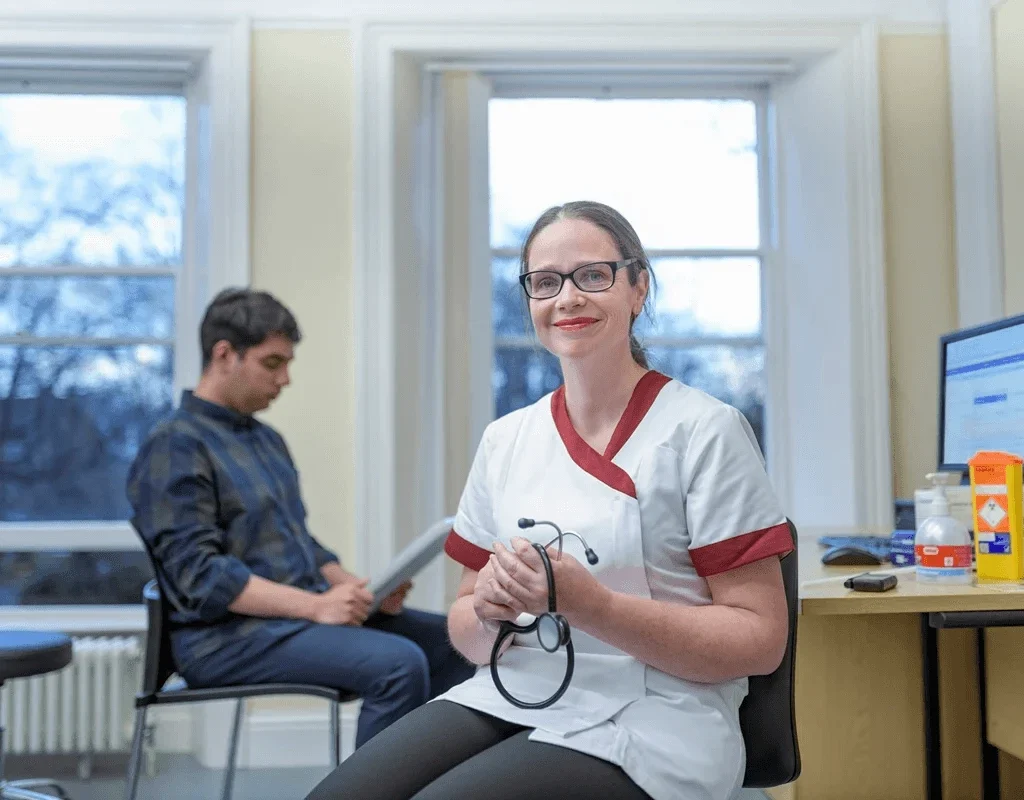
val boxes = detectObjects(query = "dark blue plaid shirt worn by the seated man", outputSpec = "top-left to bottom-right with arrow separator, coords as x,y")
128,391 -> 338,679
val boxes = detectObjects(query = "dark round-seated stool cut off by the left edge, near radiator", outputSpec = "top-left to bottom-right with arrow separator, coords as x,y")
0,631 -> 73,800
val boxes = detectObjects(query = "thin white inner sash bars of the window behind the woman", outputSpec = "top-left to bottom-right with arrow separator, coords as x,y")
485,86 -> 770,452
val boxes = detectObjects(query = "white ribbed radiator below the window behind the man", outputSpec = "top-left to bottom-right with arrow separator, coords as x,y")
0,636 -> 141,755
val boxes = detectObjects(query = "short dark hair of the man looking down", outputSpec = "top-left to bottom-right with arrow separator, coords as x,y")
199,289 -> 302,370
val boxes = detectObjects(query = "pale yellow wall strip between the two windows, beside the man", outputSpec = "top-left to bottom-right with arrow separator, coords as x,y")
252,30 -> 354,564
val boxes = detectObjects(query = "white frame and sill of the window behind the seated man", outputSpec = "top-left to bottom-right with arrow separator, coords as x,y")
0,19 -> 250,581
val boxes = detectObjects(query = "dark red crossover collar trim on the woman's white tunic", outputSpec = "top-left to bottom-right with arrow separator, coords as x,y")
551,370 -> 671,499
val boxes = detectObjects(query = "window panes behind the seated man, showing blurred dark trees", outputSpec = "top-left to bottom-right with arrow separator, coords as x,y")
0,93 -> 186,603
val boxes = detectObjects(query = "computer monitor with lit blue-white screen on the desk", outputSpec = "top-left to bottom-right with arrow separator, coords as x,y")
939,314 -> 1024,472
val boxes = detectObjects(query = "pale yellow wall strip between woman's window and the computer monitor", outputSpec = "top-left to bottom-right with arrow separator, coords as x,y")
879,35 -> 956,497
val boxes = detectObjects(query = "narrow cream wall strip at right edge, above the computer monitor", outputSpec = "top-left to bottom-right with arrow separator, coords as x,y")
993,0 -> 1024,314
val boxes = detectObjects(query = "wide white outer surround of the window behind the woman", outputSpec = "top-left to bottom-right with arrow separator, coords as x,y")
353,18 -> 893,598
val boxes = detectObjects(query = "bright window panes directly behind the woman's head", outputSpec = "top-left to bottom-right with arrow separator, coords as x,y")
488,95 -> 767,449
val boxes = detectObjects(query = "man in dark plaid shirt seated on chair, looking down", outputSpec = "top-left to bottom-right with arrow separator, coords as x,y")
128,290 -> 473,747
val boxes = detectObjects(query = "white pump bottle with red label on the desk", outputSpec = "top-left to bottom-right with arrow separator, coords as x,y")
913,472 -> 974,584
